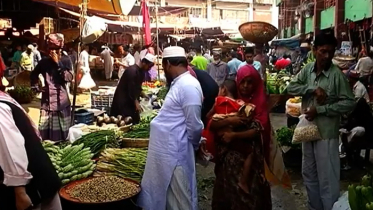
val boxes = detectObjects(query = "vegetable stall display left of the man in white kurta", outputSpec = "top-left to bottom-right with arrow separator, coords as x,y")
43,82 -> 167,210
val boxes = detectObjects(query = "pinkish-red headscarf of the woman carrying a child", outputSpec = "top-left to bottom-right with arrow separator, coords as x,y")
236,65 -> 271,161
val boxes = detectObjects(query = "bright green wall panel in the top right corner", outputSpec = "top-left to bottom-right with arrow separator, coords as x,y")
345,0 -> 372,21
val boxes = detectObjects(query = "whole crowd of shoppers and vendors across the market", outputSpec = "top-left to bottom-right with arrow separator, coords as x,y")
0,31 -> 373,210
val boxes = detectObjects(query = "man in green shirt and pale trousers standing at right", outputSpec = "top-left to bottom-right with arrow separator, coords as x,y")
287,34 -> 355,210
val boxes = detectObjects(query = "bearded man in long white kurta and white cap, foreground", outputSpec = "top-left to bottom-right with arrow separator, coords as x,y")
138,47 -> 203,210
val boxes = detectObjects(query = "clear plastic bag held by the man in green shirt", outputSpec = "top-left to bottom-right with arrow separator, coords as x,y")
292,114 -> 321,144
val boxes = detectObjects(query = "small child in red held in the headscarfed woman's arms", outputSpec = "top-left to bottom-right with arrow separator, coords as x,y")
208,80 -> 255,193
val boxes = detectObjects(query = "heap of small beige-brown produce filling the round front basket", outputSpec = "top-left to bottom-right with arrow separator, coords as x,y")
67,176 -> 140,203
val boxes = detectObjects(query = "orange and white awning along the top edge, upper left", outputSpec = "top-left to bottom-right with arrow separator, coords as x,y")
34,0 -> 136,15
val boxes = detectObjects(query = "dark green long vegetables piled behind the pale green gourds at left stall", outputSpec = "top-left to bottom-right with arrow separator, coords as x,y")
73,130 -> 120,157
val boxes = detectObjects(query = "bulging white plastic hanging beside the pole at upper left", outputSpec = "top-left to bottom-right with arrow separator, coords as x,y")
82,16 -> 107,44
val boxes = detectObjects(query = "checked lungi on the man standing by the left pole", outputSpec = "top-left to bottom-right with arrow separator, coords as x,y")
39,106 -> 71,141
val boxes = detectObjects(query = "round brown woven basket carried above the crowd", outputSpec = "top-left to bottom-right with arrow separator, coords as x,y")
238,21 -> 278,43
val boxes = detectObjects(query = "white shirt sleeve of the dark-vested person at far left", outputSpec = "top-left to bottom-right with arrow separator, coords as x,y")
0,97 -> 32,186
